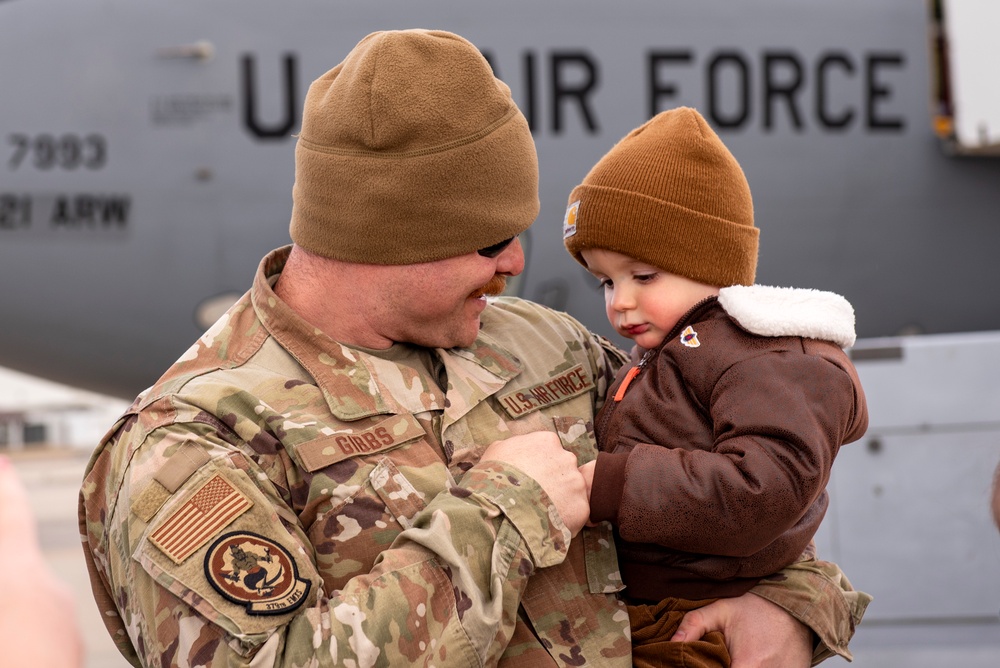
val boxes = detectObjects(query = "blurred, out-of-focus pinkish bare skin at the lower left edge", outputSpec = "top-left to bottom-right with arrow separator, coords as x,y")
0,457 -> 83,668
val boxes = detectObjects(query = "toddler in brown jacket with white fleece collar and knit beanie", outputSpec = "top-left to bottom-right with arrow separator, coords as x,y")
563,108 -> 868,666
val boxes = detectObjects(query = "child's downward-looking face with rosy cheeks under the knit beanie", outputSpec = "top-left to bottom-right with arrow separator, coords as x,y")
581,248 -> 719,348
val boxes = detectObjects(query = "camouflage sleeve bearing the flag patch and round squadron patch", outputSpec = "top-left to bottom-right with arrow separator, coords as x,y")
81,432 -> 570,668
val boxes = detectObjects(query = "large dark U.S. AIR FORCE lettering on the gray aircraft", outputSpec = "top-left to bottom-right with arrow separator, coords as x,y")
234,47 -> 906,140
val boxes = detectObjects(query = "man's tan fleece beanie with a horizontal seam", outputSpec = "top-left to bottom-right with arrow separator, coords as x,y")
290,30 -> 539,264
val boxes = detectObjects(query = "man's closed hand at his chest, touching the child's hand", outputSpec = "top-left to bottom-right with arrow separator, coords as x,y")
480,431 -> 590,536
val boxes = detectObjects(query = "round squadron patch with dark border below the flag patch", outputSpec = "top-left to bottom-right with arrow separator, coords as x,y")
205,531 -> 312,615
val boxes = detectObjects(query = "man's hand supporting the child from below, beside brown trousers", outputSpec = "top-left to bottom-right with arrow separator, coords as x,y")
671,593 -> 812,668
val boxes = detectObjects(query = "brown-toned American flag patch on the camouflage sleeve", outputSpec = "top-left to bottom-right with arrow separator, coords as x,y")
150,473 -> 253,564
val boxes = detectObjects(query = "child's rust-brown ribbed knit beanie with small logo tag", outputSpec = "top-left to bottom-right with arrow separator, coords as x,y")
563,107 -> 758,287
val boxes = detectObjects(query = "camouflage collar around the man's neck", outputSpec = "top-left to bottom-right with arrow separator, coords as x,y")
251,246 -> 521,421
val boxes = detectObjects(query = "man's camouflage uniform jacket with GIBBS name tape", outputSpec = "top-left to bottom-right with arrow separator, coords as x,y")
80,249 -> 868,668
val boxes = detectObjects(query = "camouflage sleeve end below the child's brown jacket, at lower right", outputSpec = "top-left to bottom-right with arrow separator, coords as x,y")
750,550 -> 872,666
